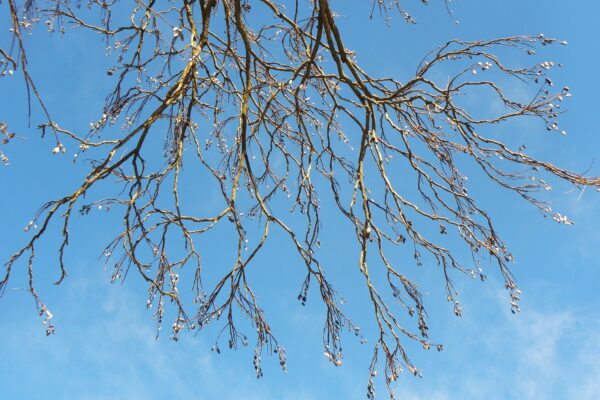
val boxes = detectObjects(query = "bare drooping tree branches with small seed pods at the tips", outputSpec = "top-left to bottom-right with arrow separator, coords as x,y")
0,0 -> 600,398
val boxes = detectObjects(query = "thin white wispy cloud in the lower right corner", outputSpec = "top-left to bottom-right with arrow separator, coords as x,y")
397,288 -> 600,400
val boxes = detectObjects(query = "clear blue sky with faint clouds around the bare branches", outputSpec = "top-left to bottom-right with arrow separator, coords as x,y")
0,0 -> 600,400
